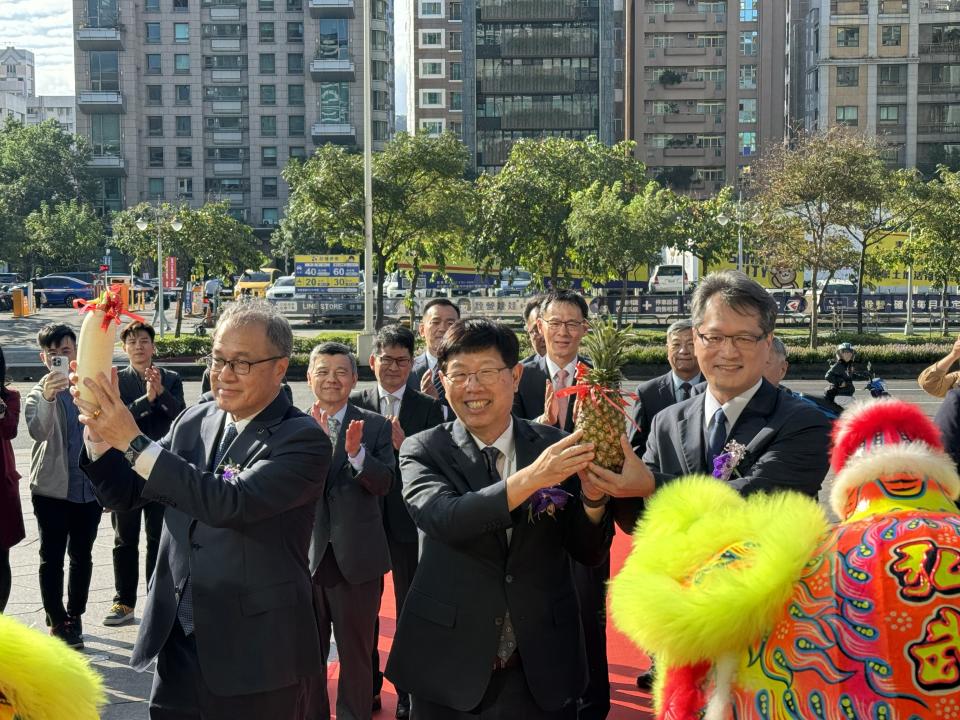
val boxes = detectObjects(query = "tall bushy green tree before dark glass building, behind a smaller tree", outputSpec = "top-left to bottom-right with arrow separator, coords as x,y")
473,137 -> 647,285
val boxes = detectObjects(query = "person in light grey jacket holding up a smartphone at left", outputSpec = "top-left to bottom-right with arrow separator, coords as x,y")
23,324 -> 103,650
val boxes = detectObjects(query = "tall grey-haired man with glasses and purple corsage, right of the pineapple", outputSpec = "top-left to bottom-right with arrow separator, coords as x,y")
588,270 -> 830,506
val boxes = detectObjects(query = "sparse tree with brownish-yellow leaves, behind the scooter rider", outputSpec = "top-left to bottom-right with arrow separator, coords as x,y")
756,127 -> 873,347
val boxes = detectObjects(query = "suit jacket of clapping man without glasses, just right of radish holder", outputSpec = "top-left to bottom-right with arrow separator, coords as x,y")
310,403 -> 395,585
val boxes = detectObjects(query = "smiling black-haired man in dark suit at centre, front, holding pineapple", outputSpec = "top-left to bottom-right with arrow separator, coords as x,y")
387,318 -> 611,720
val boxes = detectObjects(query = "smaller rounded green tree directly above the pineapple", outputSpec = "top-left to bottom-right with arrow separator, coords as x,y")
566,181 -> 676,327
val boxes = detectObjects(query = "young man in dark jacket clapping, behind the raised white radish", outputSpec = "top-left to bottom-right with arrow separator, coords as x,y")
103,320 -> 186,625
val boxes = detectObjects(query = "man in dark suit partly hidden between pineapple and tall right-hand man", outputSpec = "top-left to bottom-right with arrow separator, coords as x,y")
630,320 -> 703,454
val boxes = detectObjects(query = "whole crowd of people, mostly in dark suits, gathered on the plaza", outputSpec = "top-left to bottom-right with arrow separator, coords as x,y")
0,271 -> 960,720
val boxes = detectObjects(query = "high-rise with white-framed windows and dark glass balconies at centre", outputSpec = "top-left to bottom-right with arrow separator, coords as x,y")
407,0 -> 623,172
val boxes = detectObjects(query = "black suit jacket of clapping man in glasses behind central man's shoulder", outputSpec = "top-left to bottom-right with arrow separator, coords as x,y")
350,387 -> 443,543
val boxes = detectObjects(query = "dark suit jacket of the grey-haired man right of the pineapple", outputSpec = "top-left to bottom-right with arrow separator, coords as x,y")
643,380 -> 830,498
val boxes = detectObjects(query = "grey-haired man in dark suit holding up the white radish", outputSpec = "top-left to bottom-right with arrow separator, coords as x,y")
74,300 -> 330,720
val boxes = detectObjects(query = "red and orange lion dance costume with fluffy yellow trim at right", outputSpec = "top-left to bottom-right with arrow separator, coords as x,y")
610,400 -> 960,720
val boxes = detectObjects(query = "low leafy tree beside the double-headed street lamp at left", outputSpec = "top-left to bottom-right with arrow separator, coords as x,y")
113,202 -> 266,337
